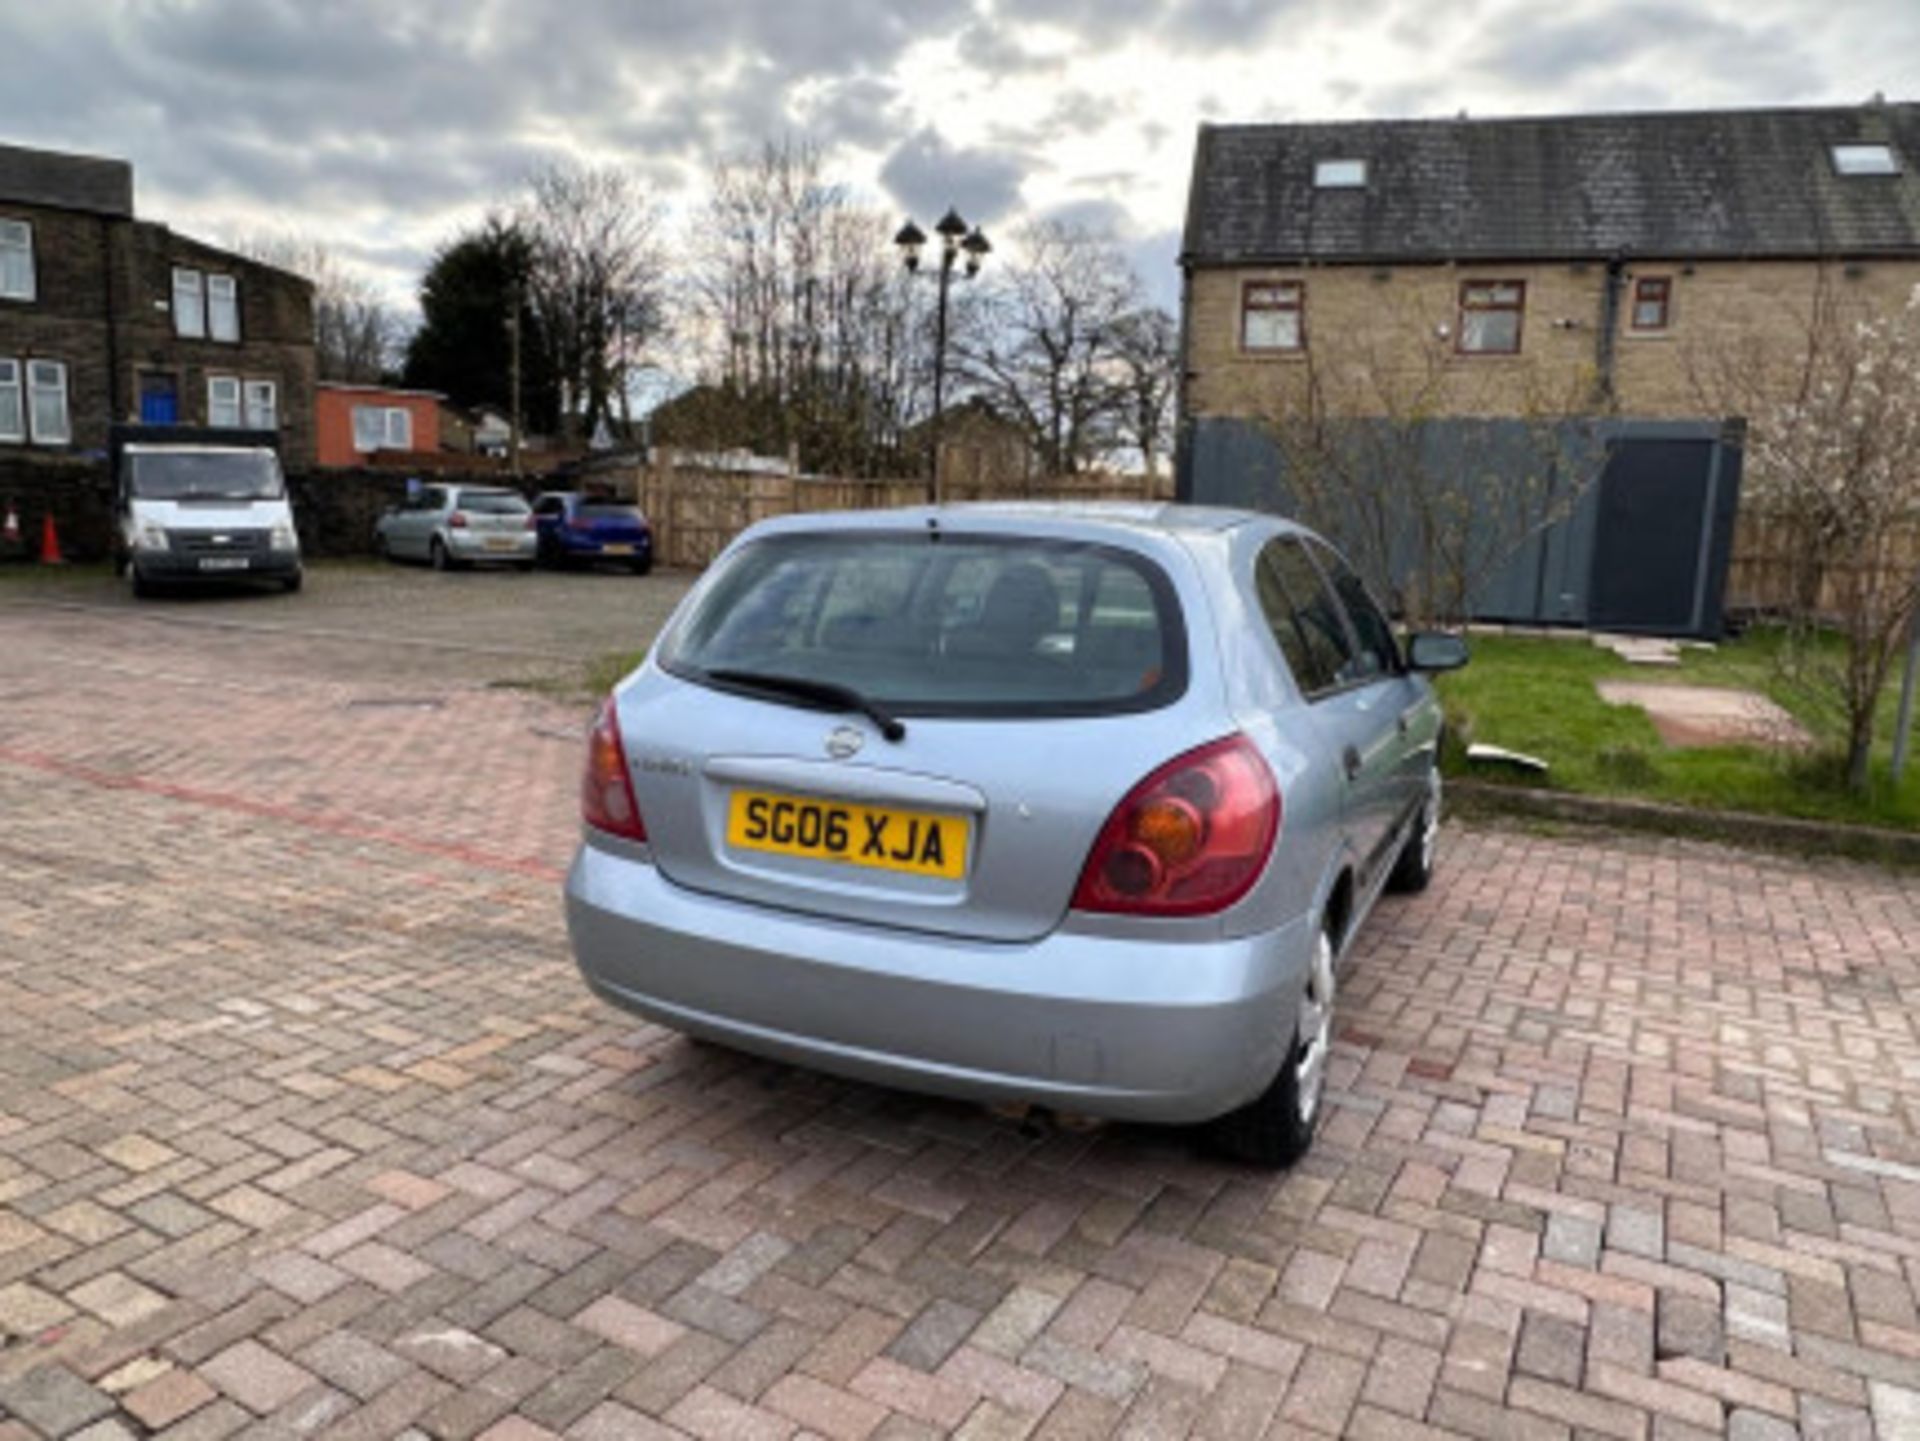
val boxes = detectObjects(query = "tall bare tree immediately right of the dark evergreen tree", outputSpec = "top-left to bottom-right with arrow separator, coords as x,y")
518,165 -> 666,434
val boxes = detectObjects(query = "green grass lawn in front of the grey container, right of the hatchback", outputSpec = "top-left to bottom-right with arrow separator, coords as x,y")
1440,631 -> 1920,829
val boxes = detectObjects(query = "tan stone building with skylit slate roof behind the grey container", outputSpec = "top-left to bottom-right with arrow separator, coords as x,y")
1181,100 -> 1920,470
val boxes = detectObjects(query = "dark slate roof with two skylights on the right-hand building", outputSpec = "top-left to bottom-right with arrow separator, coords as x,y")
1181,102 -> 1920,265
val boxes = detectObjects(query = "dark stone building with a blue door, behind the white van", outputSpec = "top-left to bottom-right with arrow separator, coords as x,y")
0,146 -> 315,470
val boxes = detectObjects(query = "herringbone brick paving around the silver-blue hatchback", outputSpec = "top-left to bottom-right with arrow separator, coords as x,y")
0,572 -> 1920,1441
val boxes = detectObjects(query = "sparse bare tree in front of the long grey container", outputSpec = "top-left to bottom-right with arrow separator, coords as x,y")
1248,289 -> 1605,626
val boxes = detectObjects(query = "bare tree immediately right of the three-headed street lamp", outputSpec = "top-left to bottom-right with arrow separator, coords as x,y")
954,221 -> 1140,476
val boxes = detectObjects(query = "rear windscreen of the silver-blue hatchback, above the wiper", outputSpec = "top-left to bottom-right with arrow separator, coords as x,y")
660,532 -> 1187,716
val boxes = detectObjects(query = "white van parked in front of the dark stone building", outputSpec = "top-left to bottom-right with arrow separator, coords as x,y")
115,439 -> 303,595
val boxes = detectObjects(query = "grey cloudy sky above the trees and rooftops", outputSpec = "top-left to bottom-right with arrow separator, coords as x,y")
0,0 -> 1920,320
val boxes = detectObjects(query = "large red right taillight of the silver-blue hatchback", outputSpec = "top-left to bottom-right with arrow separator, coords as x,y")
1073,735 -> 1281,915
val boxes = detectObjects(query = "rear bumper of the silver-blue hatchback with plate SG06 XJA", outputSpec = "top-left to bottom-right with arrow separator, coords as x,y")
566,840 -> 1313,1122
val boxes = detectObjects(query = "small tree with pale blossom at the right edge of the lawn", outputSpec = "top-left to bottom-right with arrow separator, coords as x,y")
1692,269 -> 1920,792
